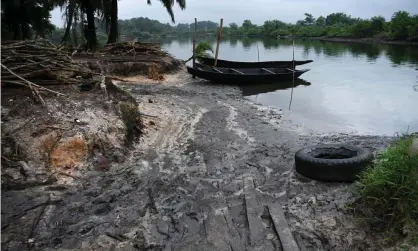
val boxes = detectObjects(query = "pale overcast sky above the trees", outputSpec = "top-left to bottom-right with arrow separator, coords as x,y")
52,0 -> 418,27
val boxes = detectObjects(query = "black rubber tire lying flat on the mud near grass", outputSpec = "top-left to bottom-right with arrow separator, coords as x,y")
295,144 -> 373,182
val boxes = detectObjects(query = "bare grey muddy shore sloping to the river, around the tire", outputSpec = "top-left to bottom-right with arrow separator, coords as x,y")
2,71 -> 391,251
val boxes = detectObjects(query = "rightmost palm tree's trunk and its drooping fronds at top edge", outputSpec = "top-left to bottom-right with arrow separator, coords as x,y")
104,0 -> 186,43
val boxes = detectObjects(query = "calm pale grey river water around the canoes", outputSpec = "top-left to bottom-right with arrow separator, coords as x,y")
162,38 -> 418,135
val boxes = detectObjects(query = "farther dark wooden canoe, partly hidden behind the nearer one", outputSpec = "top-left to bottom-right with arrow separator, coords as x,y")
197,57 -> 313,69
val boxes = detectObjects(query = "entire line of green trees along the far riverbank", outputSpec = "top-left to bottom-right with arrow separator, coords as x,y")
52,11 -> 418,46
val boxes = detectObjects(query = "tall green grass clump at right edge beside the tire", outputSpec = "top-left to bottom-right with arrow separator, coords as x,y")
351,136 -> 418,245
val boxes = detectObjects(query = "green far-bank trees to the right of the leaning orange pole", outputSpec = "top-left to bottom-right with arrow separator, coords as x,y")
223,11 -> 418,41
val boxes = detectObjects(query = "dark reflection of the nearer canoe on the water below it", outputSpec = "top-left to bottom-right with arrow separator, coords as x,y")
239,79 -> 311,96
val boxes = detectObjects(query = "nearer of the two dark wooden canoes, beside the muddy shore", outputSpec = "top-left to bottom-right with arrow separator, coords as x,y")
187,64 -> 309,84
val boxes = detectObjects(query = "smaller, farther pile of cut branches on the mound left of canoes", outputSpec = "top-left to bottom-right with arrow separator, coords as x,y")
104,42 -> 168,56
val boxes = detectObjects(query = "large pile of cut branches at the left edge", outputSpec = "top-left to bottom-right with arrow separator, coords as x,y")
1,40 -> 94,103
